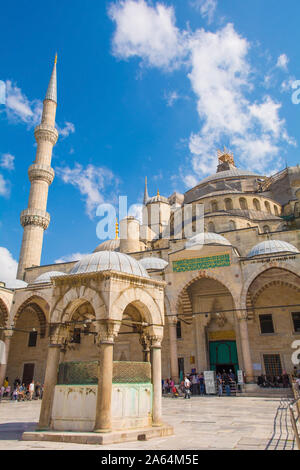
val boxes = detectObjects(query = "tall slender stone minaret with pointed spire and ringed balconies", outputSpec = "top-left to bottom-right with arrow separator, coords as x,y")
17,56 -> 58,279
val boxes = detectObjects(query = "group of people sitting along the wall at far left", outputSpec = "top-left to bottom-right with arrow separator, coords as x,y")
0,377 -> 43,402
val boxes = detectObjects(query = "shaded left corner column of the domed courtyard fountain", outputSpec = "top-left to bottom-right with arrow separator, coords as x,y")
38,342 -> 61,430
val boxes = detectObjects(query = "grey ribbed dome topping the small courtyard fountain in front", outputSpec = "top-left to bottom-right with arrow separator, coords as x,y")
70,251 -> 149,277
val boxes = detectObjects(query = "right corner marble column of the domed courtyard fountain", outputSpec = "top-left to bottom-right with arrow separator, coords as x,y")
151,337 -> 162,426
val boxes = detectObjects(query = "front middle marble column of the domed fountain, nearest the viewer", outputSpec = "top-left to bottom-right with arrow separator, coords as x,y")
94,321 -> 119,433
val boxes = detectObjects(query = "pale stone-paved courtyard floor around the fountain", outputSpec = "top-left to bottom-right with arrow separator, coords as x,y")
0,397 -> 293,450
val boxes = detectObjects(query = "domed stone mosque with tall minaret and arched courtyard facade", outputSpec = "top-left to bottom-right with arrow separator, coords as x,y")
0,60 -> 300,418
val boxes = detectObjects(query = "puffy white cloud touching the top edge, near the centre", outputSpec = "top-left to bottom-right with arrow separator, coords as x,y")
109,0 -> 185,69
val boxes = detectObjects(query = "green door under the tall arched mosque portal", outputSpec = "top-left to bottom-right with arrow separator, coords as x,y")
209,341 -> 239,374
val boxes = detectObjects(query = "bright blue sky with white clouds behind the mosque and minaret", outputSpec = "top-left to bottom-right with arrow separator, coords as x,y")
0,0 -> 300,276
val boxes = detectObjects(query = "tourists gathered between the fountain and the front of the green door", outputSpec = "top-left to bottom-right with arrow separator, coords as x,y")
162,369 -> 236,399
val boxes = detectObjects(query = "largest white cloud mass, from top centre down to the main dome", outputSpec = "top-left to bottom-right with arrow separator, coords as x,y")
110,0 -> 295,184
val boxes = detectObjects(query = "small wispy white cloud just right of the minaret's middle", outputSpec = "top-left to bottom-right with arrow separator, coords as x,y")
56,163 -> 118,218
